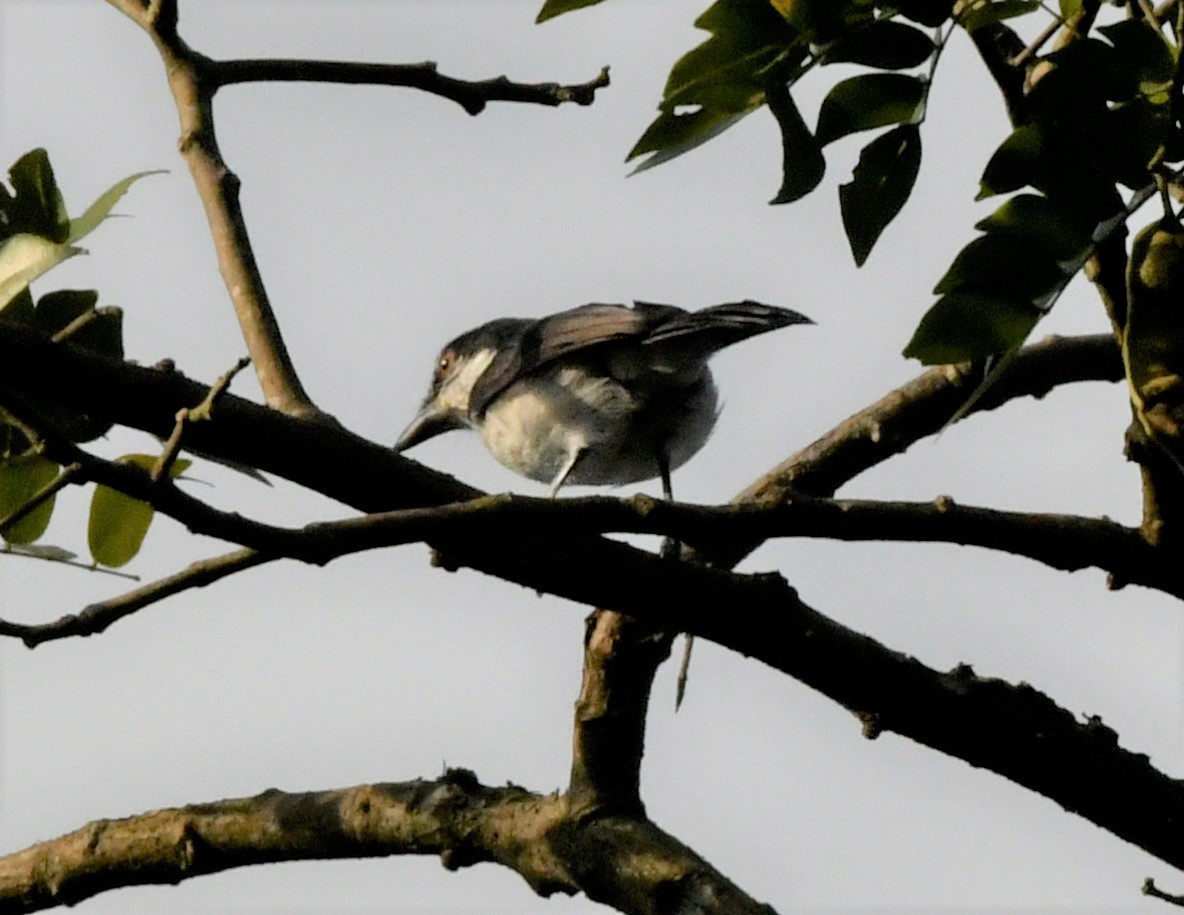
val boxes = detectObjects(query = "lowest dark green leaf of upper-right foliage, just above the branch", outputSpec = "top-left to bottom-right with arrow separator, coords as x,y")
905,289 -> 1042,366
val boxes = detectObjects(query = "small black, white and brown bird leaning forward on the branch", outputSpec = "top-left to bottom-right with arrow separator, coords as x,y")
394,301 -> 813,498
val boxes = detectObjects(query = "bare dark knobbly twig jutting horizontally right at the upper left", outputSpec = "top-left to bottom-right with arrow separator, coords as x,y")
211,59 -> 609,115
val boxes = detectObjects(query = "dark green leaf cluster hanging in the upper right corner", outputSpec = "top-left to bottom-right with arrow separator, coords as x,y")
539,0 -> 1184,363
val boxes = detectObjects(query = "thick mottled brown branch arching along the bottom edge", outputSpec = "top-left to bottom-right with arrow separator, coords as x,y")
0,769 -> 773,915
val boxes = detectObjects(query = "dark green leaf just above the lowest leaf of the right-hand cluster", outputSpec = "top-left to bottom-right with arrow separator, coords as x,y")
933,234 -> 1066,303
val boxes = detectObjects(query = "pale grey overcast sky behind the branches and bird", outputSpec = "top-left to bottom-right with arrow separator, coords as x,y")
0,0 -> 1184,914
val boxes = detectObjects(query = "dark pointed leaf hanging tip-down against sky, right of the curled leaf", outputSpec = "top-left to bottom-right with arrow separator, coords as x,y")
838,124 -> 921,265
